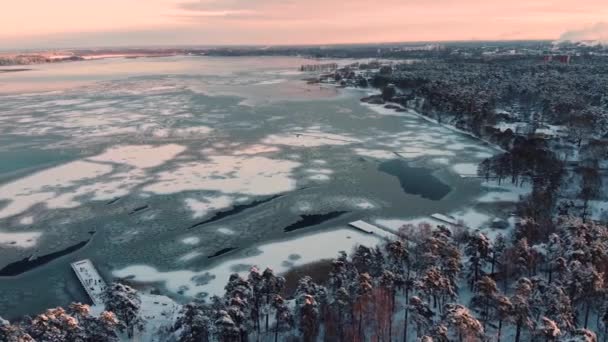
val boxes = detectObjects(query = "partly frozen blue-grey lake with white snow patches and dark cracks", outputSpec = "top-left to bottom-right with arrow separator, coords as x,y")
0,57 -> 517,317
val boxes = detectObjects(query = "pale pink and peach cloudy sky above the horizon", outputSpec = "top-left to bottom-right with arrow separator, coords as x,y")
0,0 -> 608,49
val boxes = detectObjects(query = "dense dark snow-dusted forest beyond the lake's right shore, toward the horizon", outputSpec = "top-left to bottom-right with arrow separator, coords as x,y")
337,56 -> 608,145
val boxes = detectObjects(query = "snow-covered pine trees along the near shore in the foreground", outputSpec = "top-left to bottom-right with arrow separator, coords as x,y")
0,217 -> 608,342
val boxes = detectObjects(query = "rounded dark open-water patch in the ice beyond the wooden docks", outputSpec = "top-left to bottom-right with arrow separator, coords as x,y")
378,159 -> 452,201
